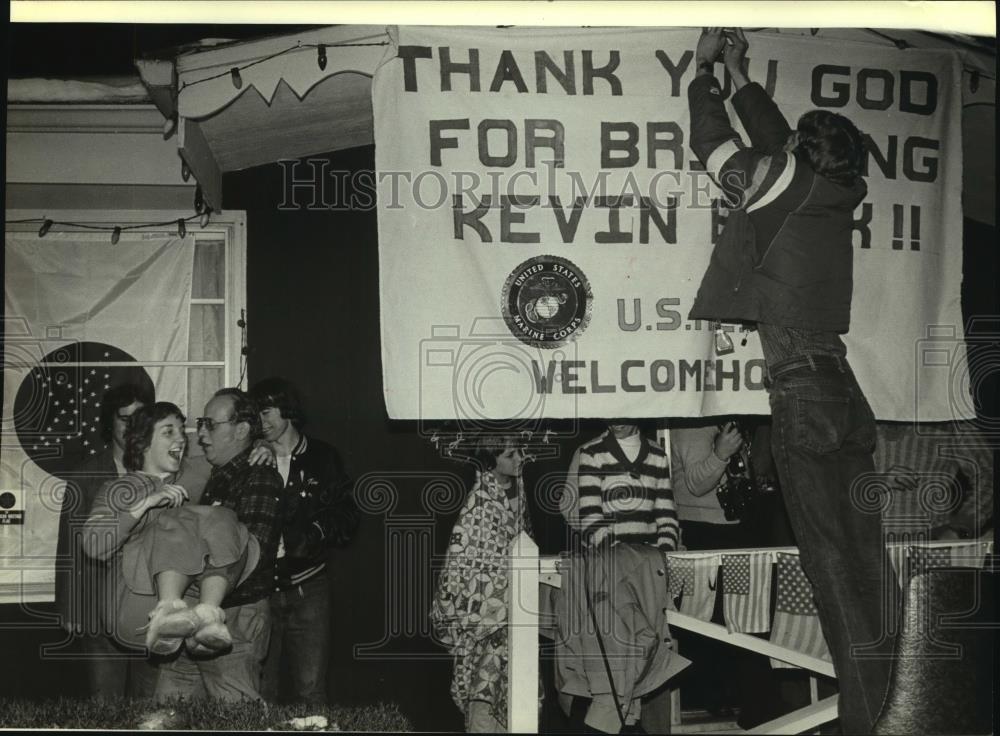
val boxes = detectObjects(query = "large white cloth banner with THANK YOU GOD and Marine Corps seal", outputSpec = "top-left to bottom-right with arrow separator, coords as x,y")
374,28 -> 971,426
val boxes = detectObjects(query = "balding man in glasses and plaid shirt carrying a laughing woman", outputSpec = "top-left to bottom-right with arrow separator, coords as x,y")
155,388 -> 283,701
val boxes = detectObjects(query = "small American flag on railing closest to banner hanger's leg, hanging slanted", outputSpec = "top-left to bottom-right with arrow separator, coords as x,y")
771,552 -> 831,667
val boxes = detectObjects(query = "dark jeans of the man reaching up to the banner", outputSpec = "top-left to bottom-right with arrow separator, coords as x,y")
768,356 -> 896,734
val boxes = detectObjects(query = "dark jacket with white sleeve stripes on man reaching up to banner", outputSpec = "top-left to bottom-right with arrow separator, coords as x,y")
688,75 -> 867,333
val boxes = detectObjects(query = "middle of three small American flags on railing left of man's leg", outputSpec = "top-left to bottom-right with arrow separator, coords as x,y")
722,552 -> 771,634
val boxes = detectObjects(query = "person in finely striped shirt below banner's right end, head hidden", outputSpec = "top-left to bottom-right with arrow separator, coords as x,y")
875,421 -> 994,540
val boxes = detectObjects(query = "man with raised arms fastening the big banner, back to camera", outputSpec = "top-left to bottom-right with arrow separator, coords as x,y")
688,28 -> 897,733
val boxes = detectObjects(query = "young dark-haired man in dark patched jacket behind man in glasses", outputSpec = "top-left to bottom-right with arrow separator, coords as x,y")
250,378 -> 359,705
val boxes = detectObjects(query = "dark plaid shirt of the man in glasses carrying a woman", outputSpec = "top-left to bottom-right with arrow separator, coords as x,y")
201,448 -> 282,608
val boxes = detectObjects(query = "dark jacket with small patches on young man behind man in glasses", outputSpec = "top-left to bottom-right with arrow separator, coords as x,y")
275,434 -> 359,590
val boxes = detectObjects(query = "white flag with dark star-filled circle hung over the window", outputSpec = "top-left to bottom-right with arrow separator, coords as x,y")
0,232 -> 195,584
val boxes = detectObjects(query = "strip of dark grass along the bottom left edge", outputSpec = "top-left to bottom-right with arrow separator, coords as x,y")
0,698 -> 413,733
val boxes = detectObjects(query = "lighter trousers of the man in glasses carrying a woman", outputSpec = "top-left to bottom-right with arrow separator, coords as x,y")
156,600 -> 271,702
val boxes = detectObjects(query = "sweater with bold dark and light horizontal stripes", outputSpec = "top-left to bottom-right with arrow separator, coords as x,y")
578,430 -> 678,550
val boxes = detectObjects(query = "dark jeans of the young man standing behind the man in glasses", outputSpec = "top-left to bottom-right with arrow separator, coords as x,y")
263,571 -> 330,705
